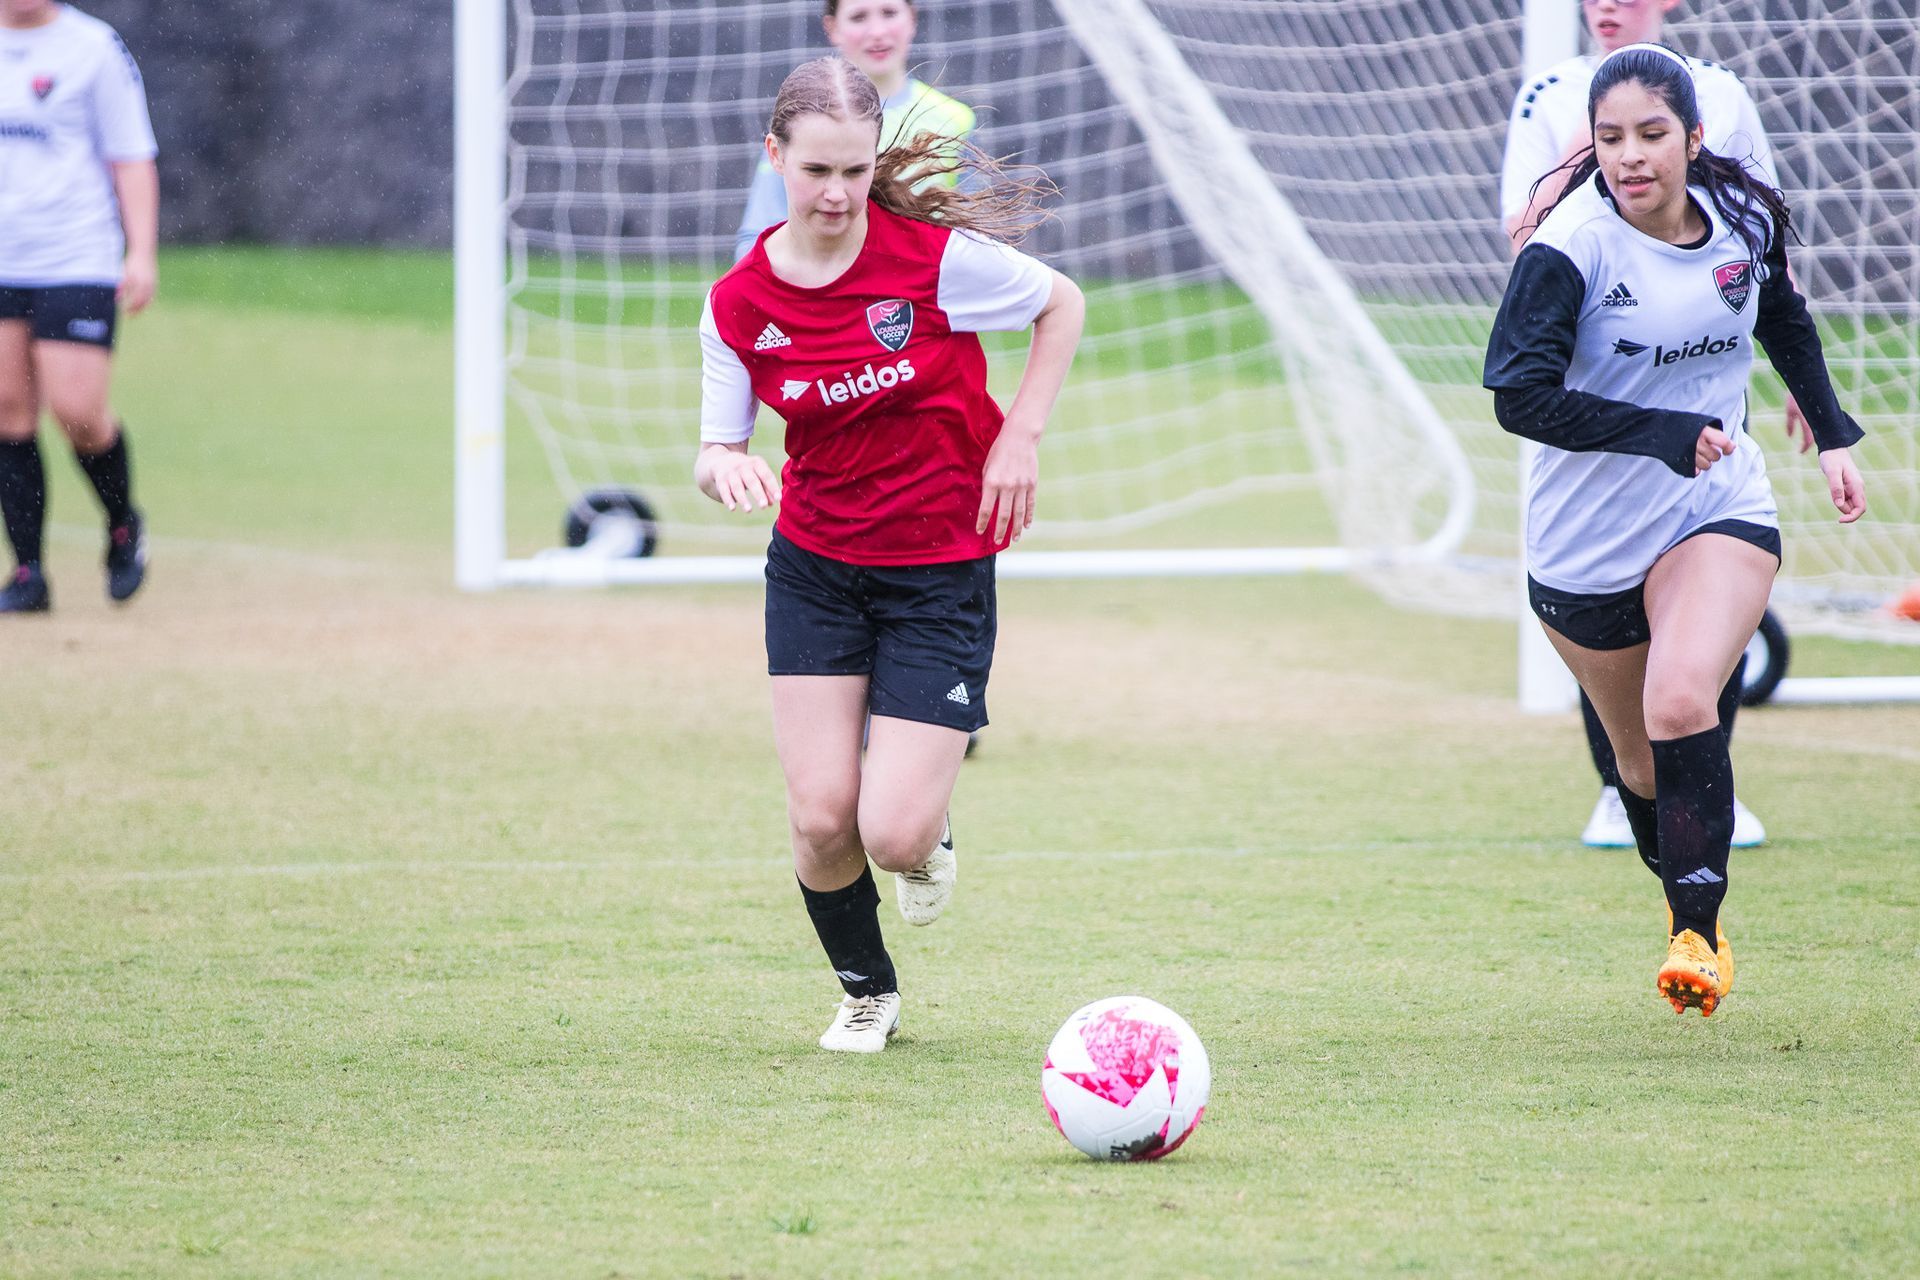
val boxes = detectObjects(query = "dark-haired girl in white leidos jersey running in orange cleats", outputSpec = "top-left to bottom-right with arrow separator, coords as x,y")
1484,44 -> 1866,1015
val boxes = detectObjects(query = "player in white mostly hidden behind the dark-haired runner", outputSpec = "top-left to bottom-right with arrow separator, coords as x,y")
1500,0 -> 1781,848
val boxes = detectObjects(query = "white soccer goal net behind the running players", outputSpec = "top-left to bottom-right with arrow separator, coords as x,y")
463,0 -> 1920,639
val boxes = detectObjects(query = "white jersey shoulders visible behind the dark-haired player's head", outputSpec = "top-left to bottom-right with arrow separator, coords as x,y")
1500,56 -> 1780,219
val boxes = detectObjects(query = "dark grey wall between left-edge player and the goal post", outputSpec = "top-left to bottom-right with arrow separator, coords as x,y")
91,0 -> 453,246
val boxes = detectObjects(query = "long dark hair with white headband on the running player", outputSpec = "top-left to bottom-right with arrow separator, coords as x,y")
1534,44 -> 1793,263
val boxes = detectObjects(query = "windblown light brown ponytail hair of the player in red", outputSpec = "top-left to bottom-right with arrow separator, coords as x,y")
766,54 -> 1060,244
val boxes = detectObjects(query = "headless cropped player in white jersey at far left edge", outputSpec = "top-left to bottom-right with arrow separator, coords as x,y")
0,0 -> 159,612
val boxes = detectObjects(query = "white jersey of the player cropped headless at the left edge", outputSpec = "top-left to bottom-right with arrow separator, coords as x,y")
0,6 -> 157,286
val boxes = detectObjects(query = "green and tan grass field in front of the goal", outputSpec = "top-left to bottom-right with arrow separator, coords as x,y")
0,253 -> 1920,1280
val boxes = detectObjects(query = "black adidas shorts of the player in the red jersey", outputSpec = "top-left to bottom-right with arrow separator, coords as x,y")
766,530 -> 998,733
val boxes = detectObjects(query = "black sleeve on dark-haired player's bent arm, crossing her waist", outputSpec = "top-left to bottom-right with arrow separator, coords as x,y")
1480,244 -> 1720,478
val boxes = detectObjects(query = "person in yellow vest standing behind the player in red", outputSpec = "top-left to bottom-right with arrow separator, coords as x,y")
733,0 -> 973,261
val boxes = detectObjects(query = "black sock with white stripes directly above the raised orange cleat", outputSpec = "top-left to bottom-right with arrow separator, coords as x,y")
1653,725 -> 1734,946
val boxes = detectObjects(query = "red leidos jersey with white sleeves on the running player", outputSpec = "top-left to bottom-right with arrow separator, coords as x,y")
701,203 -> 1052,564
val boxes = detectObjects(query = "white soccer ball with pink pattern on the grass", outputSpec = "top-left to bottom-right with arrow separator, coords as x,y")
1041,996 -> 1213,1159
